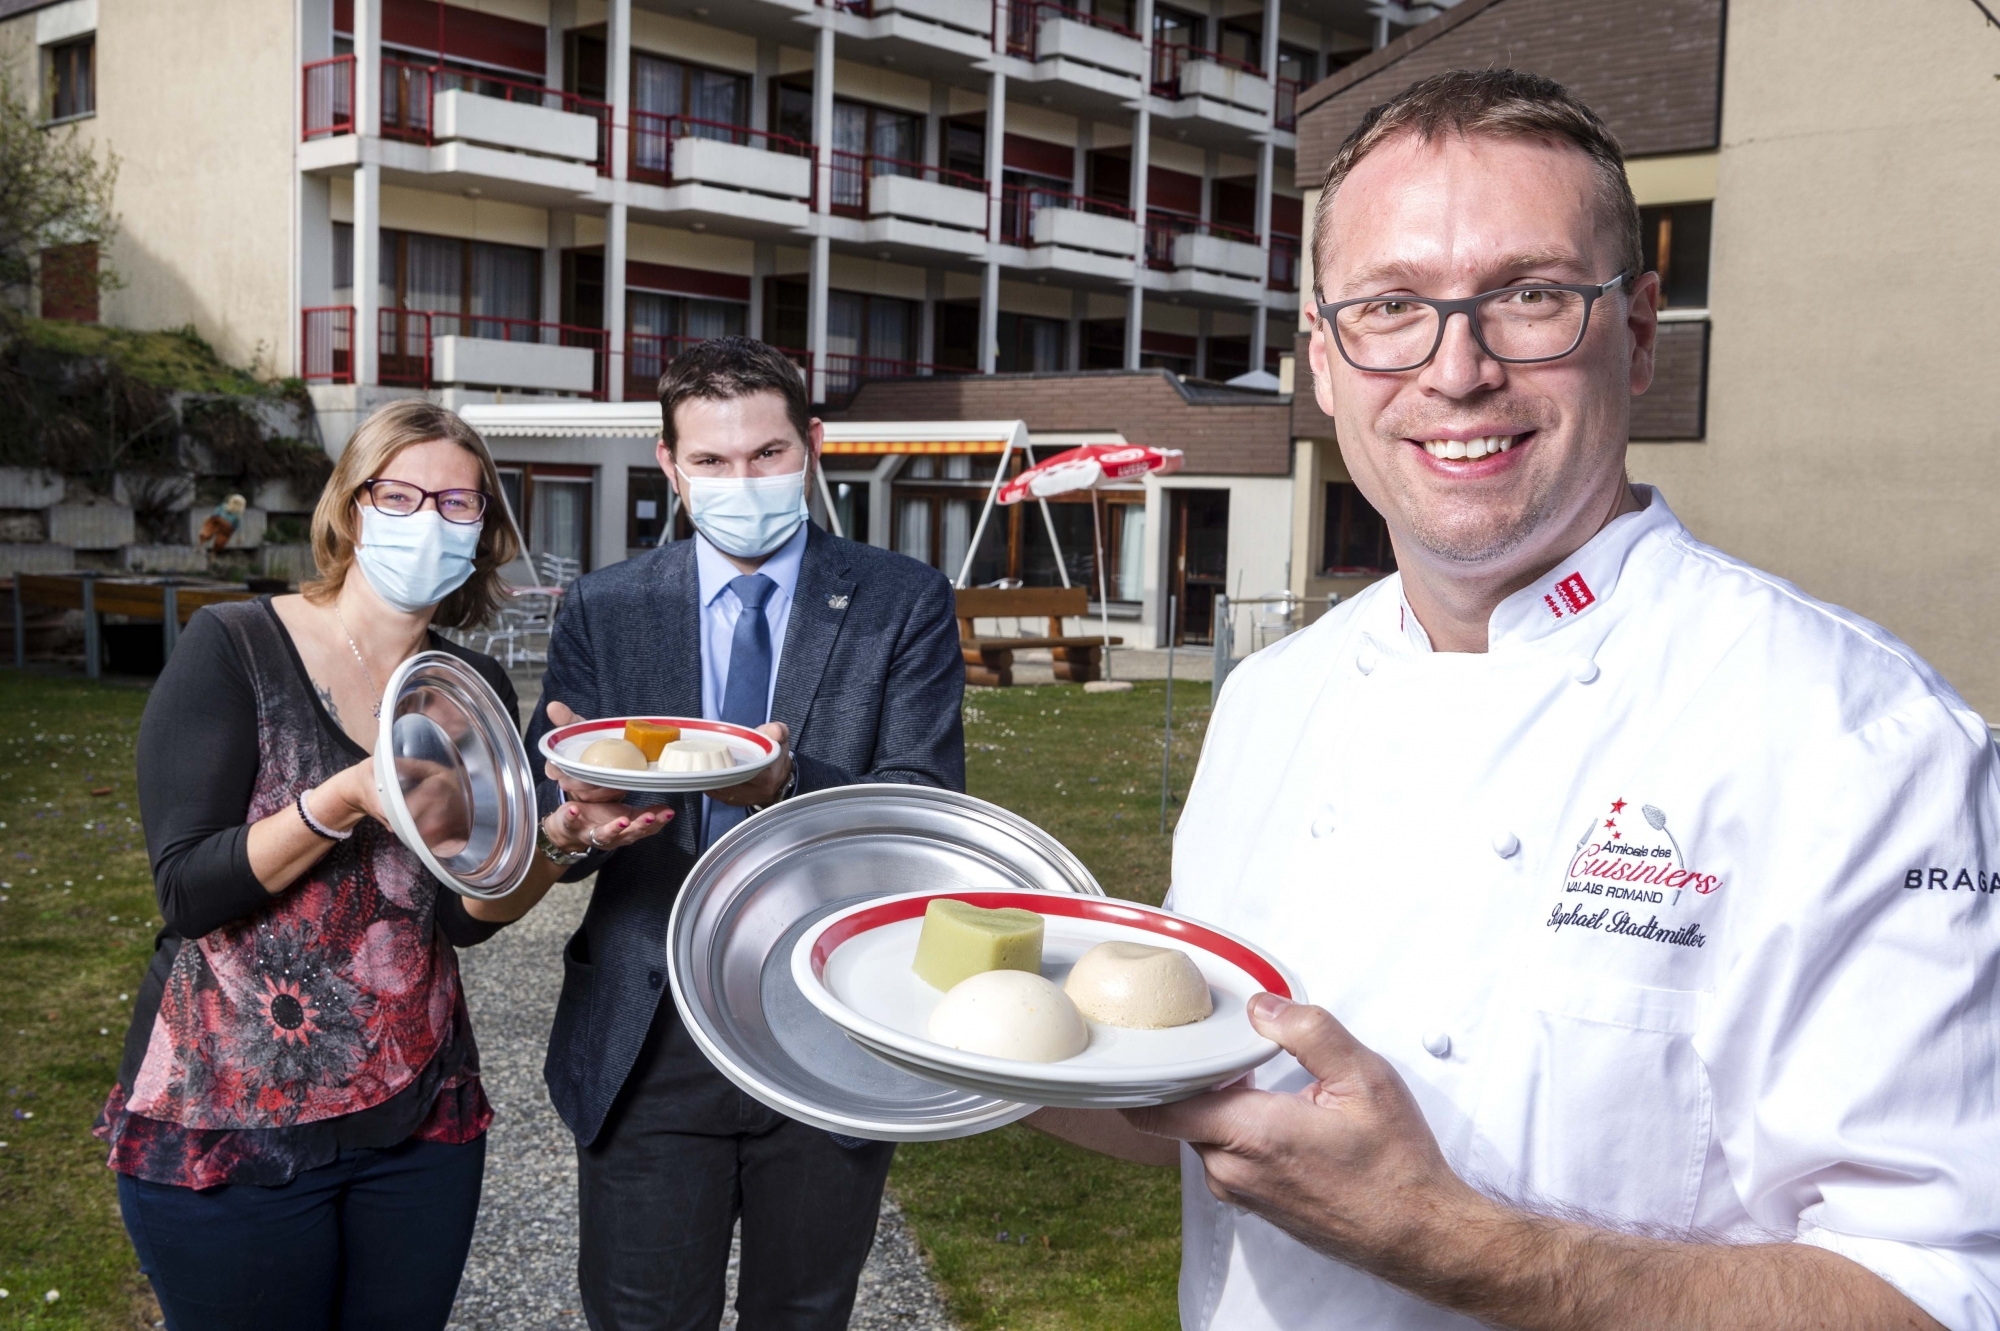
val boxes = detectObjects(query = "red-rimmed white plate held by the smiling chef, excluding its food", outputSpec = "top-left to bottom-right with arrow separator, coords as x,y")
792,891 -> 1304,1109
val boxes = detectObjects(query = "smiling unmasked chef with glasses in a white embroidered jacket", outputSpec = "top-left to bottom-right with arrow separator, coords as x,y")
1034,70 -> 2000,1331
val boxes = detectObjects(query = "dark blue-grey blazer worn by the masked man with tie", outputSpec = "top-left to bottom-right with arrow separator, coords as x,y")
528,528 -> 966,1145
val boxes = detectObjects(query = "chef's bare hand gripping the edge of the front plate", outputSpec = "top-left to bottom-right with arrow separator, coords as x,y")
1124,993 -> 1492,1279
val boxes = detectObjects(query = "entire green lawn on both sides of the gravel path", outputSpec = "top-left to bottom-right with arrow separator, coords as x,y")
0,671 -> 1208,1331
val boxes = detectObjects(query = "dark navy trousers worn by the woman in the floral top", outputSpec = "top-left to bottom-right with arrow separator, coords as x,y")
118,1137 -> 486,1331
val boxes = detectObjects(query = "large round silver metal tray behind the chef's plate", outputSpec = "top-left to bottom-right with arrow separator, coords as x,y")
666,785 -> 1104,1141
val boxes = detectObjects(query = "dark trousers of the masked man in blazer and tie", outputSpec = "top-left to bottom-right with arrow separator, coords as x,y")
576,1003 -> 896,1331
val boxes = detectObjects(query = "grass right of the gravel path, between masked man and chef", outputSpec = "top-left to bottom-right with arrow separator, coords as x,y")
890,683 -> 1208,1331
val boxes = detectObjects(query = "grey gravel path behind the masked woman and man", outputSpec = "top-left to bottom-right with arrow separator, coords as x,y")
450,875 -> 952,1331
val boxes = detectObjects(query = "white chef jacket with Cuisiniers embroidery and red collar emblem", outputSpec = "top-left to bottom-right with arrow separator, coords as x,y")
1168,488 -> 2000,1331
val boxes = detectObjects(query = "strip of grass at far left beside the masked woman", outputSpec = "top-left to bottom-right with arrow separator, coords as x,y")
0,671 -> 158,1329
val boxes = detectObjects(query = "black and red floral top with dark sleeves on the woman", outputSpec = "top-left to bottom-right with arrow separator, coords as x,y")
98,600 -> 514,1187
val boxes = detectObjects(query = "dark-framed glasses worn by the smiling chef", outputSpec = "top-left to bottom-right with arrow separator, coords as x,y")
1320,272 -> 1632,374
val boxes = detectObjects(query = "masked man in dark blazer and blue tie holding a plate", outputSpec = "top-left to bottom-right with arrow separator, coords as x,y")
528,338 -> 966,1331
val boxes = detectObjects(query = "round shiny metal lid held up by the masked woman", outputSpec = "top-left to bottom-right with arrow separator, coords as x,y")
374,652 -> 536,897
